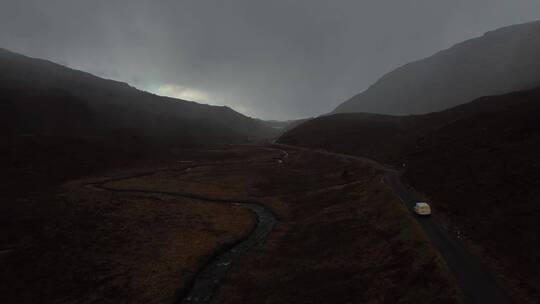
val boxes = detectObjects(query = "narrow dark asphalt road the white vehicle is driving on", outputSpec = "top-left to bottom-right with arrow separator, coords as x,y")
276,144 -> 512,304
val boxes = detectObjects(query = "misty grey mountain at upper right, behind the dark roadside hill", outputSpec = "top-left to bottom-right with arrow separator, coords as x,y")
333,21 -> 540,115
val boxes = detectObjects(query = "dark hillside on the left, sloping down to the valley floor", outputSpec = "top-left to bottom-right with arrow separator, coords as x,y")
0,49 -> 276,196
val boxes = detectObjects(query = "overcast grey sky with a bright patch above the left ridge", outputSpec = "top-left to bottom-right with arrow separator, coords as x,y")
0,0 -> 540,119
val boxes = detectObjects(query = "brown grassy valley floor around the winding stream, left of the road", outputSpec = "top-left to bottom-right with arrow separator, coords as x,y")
0,145 -> 461,303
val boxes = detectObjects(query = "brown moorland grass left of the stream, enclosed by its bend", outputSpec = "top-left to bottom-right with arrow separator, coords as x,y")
0,171 -> 256,303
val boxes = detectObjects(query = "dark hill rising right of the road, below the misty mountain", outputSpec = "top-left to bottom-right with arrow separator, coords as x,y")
279,88 -> 540,303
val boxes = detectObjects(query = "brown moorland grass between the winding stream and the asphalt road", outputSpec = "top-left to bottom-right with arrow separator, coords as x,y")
125,146 -> 460,303
